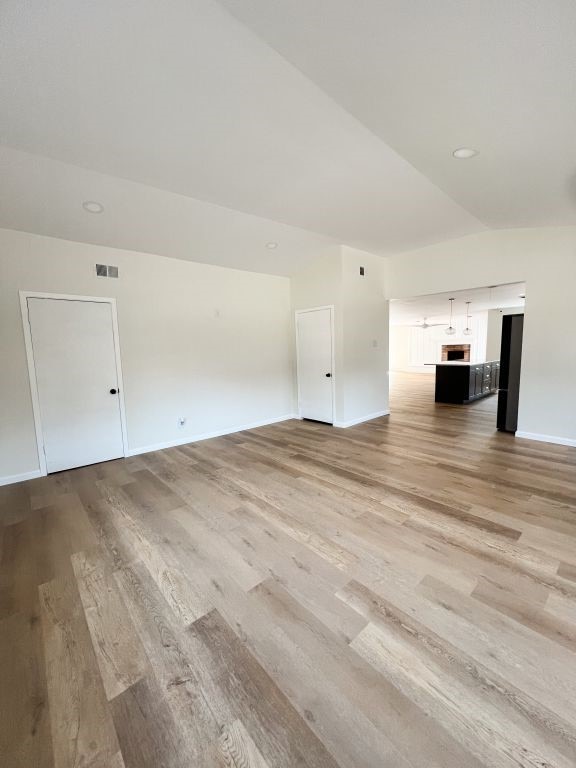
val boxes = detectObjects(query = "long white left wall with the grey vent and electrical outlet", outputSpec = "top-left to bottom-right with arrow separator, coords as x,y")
0,230 -> 295,480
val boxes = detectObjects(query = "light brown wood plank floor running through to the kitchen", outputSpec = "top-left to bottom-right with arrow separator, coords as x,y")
0,368 -> 576,768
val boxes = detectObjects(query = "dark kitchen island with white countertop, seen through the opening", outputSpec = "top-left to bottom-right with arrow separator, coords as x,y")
434,360 -> 500,405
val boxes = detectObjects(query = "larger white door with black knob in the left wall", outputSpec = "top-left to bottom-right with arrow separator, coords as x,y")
28,297 -> 124,472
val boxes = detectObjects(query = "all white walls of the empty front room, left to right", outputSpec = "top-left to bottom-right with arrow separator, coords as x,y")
0,222 -> 576,480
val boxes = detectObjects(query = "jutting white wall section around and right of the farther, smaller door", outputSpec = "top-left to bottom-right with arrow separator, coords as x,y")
291,246 -> 388,426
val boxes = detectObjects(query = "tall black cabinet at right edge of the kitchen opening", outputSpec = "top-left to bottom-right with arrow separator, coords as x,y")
496,315 -> 524,432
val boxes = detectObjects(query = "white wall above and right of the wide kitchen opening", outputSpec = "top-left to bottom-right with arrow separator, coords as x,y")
385,227 -> 576,445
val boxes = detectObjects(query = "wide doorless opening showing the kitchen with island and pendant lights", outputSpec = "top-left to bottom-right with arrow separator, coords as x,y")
390,282 -> 526,432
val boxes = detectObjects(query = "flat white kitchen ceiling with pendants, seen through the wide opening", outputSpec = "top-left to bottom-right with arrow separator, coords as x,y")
390,283 -> 526,325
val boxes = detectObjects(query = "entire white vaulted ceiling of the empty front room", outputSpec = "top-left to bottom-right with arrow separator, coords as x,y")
0,0 -> 576,274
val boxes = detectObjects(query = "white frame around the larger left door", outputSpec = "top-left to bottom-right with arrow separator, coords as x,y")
19,291 -> 128,477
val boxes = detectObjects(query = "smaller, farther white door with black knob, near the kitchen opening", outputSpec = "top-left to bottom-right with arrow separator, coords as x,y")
296,308 -> 334,424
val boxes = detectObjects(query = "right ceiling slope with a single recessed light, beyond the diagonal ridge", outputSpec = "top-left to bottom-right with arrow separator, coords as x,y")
221,0 -> 576,228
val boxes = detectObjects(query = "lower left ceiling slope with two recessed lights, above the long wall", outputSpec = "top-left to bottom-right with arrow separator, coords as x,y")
0,147 -> 336,276
